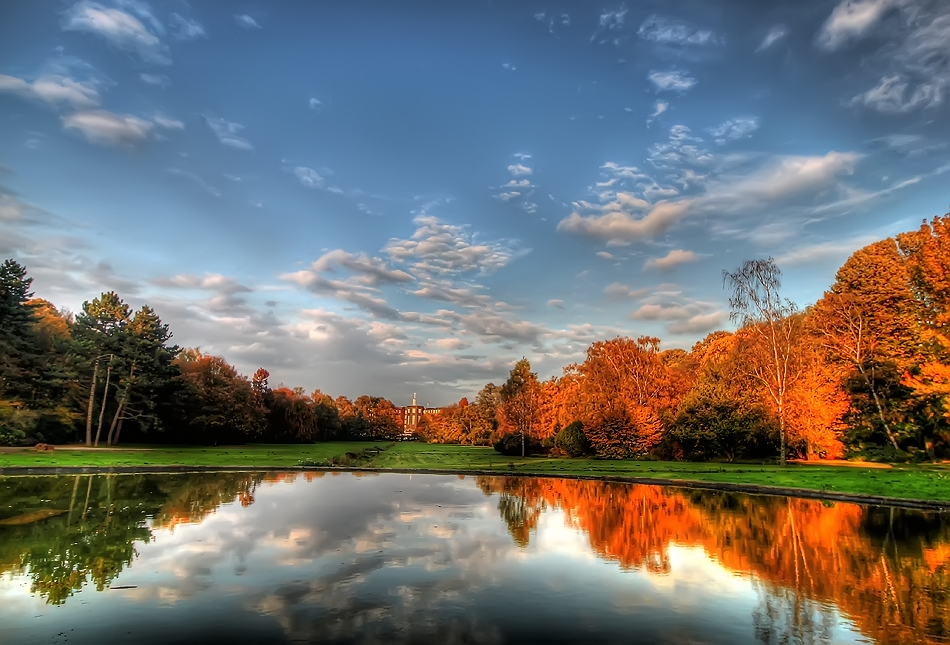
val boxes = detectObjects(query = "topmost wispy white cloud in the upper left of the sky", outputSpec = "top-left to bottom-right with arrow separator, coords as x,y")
62,0 -> 171,65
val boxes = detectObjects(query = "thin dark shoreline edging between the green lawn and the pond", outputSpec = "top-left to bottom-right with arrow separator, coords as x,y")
0,465 -> 950,513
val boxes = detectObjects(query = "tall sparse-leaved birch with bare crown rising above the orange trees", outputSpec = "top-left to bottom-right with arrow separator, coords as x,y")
722,258 -> 802,466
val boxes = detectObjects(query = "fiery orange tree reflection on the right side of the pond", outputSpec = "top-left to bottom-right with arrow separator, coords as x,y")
477,477 -> 950,644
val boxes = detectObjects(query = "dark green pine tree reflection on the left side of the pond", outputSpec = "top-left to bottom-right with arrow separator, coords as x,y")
0,473 -> 276,605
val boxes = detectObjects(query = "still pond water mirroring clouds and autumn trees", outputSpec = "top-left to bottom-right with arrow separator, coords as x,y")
0,473 -> 950,645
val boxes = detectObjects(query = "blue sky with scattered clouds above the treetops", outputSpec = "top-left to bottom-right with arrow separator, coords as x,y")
0,0 -> 950,405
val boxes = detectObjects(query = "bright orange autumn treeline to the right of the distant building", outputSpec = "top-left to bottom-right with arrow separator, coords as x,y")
419,215 -> 950,462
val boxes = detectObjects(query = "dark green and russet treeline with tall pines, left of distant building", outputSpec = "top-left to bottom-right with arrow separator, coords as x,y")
0,260 -> 402,446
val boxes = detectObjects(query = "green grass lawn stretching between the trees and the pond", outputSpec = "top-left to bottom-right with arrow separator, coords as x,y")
0,442 -> 950,502
